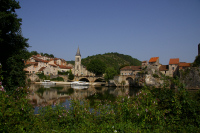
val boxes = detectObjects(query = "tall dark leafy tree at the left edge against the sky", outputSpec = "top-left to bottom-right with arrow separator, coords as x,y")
0,0 -> 30,90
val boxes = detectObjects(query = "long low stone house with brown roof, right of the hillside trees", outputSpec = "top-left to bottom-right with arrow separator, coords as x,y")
120,66 -> 142,76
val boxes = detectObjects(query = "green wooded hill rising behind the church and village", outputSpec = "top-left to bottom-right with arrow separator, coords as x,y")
82,53 -> 141,70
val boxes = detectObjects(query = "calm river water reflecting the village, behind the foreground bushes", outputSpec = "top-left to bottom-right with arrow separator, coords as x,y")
29,84 -> 140,114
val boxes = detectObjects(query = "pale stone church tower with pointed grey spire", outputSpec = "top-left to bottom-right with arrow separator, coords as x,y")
74,47 -> 82,76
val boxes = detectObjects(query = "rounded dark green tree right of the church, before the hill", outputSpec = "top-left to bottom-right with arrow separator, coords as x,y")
87,59 -> 106,75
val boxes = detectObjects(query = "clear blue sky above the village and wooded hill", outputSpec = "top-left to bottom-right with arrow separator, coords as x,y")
16,0 -> 200,65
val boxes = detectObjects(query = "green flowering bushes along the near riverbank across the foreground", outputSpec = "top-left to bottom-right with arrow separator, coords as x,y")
0,74 -> 200,132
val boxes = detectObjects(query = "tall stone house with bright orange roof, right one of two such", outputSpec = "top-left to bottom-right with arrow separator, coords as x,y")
169,58 -> 179,77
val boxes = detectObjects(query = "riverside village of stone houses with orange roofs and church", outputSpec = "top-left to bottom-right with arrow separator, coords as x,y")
24,46 -> 197,86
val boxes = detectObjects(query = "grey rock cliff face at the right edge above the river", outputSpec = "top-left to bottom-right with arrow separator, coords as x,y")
180,67 -> 200,89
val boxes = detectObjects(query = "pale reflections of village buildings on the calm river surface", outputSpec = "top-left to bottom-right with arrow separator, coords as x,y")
29,84 -> 140,106
